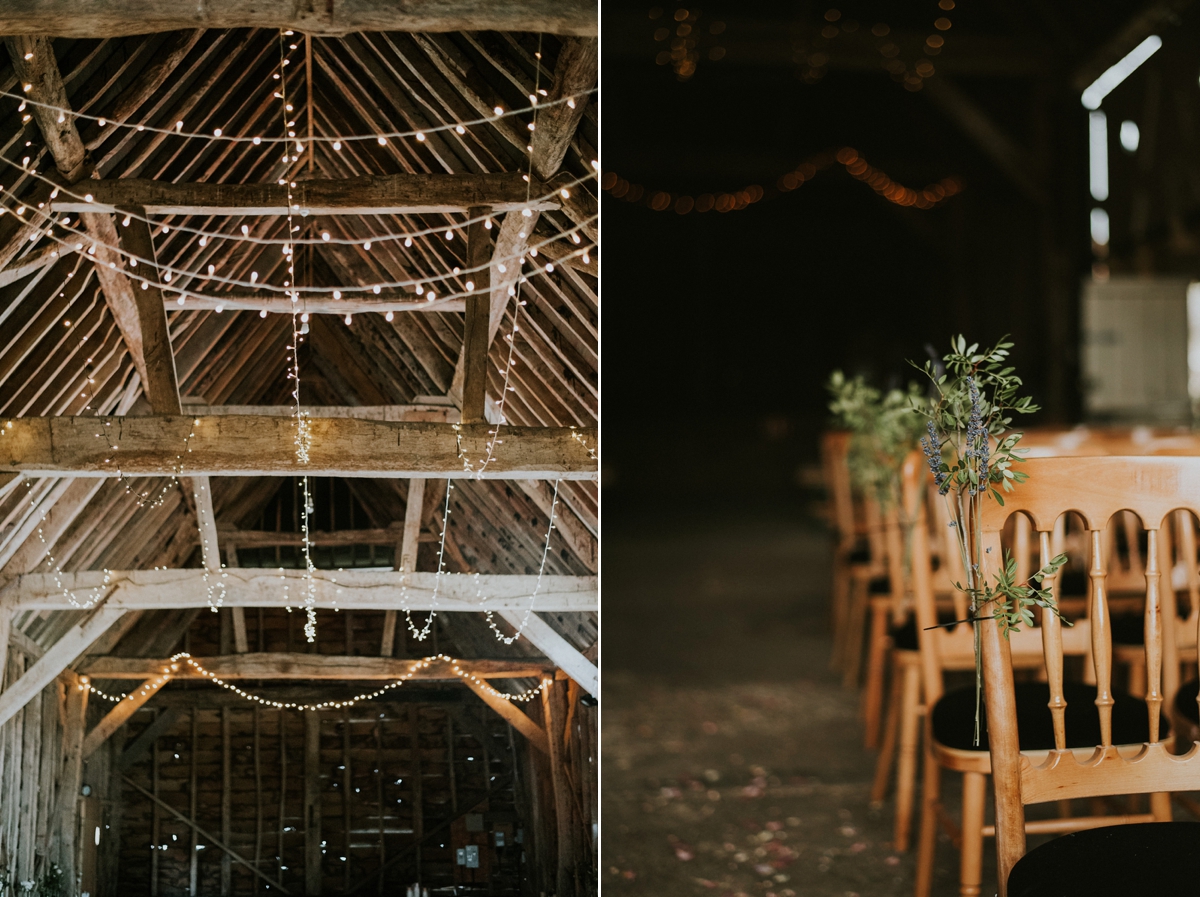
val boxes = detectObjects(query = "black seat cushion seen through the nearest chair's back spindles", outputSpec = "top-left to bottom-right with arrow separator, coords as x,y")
934,682 -> 1169,751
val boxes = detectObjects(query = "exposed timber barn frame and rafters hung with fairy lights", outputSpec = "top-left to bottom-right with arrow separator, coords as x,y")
0,0 -> 599,895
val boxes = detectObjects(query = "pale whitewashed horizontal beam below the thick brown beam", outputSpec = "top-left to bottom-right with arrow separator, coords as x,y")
2,567 -> 599,613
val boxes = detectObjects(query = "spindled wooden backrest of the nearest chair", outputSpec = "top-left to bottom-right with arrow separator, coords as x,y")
980,457 -> 1200,893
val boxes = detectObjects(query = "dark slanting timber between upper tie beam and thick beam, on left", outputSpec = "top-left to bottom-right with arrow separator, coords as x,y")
115,206 -> 182,414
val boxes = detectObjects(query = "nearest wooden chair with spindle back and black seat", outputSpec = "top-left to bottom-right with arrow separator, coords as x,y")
980,457 -> 1200,897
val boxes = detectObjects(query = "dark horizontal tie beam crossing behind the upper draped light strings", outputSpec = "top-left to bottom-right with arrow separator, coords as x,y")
50,171 -> 562,216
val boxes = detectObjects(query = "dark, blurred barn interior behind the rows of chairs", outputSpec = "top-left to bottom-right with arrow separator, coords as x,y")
601,0 -> 1200,515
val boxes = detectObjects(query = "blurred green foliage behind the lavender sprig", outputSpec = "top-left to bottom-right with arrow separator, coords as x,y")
826,371 -> 923,505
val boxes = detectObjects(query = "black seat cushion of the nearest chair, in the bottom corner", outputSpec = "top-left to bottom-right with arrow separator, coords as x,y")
1008,823 -> 1200,897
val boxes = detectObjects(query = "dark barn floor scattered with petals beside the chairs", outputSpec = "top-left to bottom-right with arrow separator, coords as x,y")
601,508 -> 974,897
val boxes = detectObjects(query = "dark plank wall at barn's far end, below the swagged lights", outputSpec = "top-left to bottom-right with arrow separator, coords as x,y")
115,702 -> 523,897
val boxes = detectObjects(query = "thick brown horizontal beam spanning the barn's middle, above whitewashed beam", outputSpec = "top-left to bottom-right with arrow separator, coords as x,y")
0,415 -> 598,480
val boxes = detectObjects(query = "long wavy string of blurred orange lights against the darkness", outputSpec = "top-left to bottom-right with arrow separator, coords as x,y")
600,146 -> 962,215
